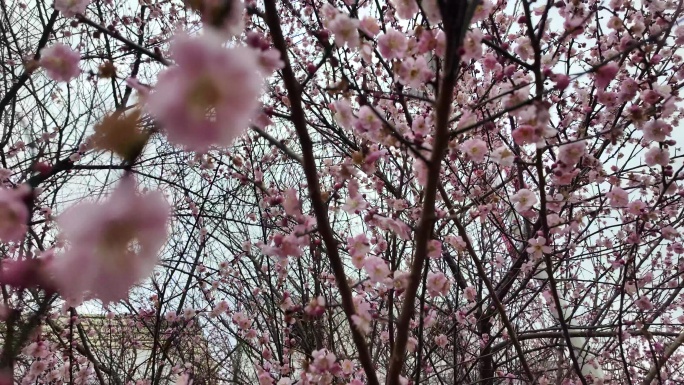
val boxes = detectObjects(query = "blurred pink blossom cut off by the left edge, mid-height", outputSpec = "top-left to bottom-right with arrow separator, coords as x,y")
0,187 -> 30,242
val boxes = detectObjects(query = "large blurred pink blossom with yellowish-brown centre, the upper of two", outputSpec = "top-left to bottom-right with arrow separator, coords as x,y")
147,34 -> 263,151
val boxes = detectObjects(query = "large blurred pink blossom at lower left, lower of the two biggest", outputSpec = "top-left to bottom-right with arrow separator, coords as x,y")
47,178 -> 169,303
